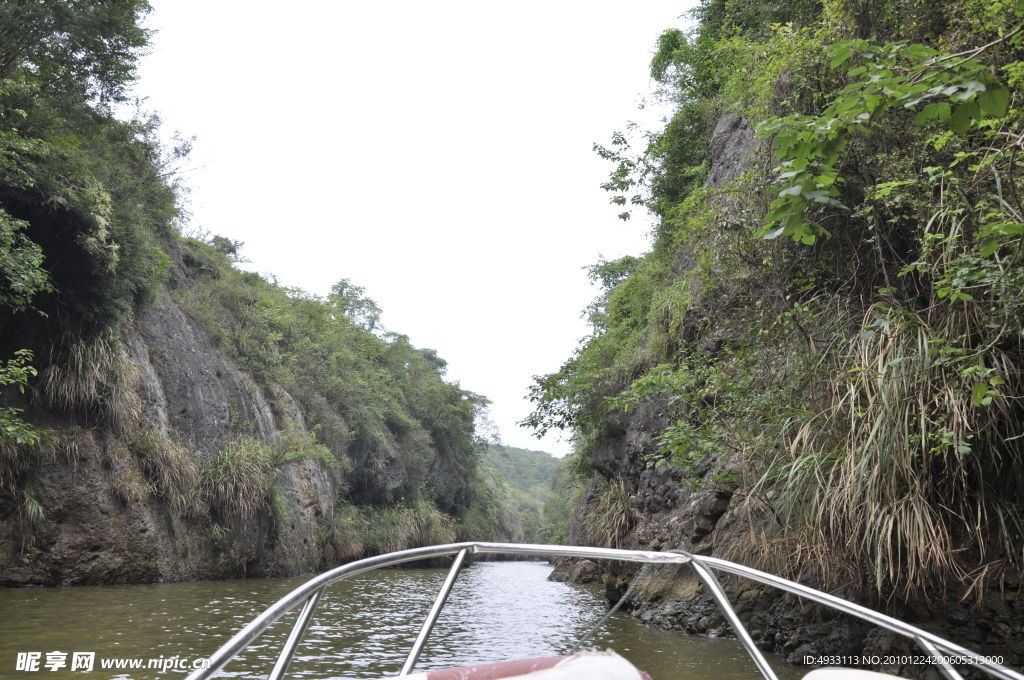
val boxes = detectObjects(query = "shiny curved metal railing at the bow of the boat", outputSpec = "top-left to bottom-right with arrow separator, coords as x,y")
185,543 -> 1024,680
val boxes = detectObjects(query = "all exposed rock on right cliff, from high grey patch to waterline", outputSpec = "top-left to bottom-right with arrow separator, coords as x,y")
553,115 -> 1024,677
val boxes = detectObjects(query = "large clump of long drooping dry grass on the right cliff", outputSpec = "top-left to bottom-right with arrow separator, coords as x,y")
771,308 -> 1024,594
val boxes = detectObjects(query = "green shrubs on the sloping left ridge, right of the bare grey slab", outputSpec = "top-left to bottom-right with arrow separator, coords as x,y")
174,239 -> 486,512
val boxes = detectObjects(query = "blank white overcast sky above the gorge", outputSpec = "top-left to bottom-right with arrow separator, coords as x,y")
135,0 -> 693,456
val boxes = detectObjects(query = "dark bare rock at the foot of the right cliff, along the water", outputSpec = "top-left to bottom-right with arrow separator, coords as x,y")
577,395 -> 1024,677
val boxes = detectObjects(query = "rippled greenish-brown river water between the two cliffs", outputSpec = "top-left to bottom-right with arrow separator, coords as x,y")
0,562 -> 802,680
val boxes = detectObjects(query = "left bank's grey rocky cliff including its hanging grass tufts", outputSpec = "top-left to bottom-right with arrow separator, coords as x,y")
0,242 -> 469,586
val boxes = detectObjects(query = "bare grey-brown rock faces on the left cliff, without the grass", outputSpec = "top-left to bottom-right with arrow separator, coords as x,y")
0,295 -> 335,586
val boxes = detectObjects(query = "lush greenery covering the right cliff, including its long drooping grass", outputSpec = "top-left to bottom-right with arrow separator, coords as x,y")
526,0 -> 1024,596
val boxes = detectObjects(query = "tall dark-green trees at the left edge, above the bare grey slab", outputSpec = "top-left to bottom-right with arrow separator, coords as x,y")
0,0 -> 169,443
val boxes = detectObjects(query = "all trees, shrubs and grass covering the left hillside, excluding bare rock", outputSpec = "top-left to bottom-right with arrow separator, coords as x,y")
0,0 -> 537,559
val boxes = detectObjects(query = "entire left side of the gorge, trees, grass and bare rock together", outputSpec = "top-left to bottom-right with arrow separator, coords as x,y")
0,0 -> 561,584
